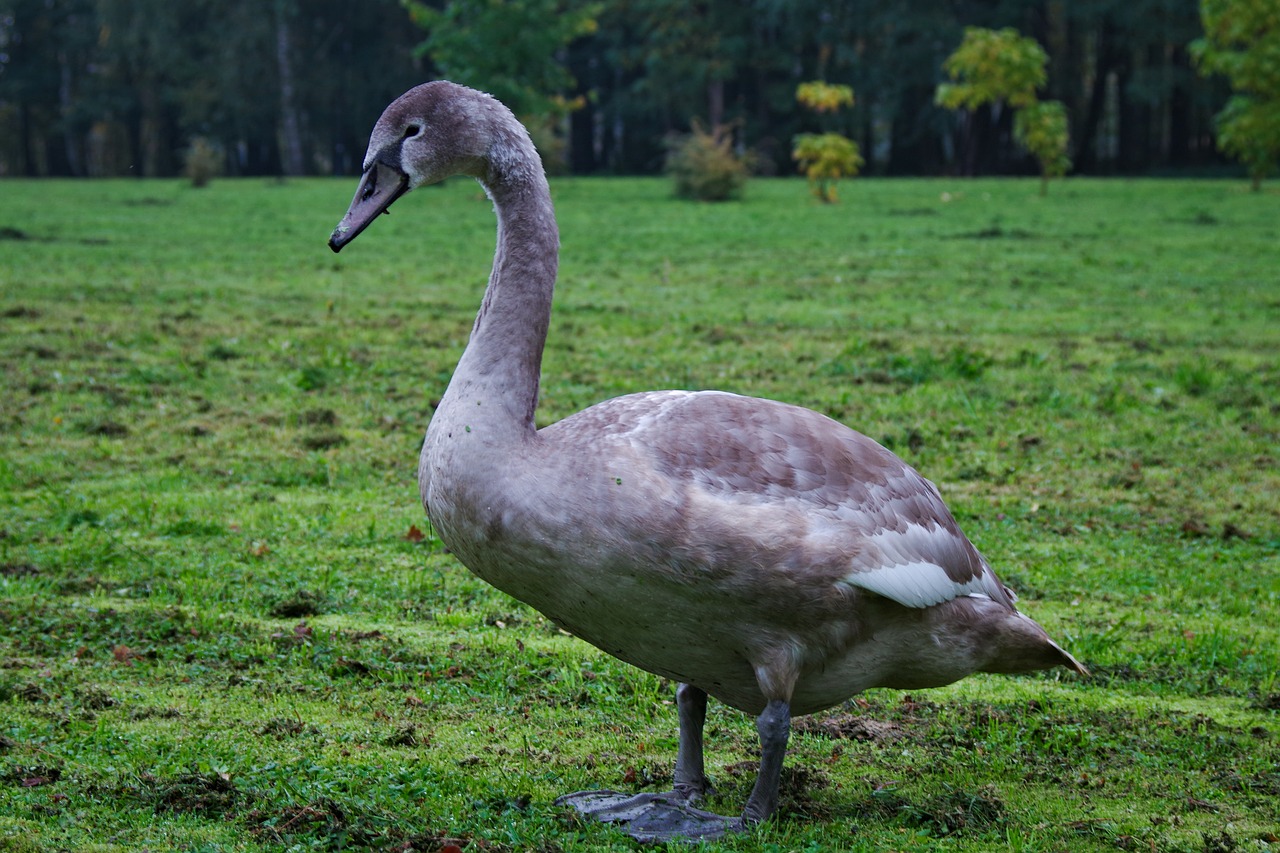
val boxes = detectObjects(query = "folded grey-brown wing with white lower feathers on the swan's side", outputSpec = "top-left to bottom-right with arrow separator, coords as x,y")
548,391 -> 1012,608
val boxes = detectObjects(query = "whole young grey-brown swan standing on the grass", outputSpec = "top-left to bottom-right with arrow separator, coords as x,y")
329,81 -> 1085,840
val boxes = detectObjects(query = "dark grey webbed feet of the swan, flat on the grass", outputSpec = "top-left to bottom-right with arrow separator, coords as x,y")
556,790 -> 745,844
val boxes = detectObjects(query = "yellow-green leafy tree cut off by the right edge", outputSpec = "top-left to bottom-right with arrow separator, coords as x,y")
1192,0 -> 1280,191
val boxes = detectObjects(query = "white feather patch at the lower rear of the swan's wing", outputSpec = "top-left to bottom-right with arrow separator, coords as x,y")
844,525 -> 1002,607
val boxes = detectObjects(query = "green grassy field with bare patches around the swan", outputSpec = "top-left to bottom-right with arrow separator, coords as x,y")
0,179 -> 1280,853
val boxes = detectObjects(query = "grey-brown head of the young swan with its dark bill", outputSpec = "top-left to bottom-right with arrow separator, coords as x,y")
329,81 -> 529,252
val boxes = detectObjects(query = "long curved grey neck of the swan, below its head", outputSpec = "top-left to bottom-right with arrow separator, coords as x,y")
440,143 -> 559,433
